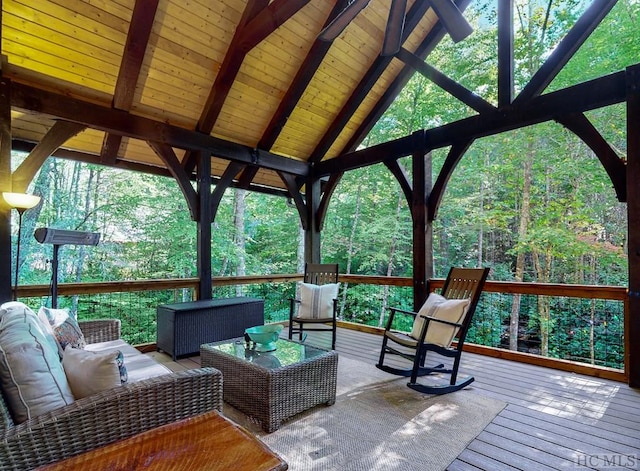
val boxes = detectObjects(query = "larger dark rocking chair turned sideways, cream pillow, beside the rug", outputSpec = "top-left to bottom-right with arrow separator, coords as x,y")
376,267 -> 489,394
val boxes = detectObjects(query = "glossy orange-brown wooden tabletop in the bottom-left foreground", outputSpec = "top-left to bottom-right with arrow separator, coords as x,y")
38,411 -> 288,471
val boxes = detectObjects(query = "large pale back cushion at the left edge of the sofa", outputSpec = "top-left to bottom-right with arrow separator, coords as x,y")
0,302 -> 74,423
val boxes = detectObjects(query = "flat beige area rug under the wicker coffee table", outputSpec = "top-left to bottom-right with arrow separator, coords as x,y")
224,357 -> 506,471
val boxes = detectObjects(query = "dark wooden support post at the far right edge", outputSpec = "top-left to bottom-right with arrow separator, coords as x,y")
625,65 -> 640,388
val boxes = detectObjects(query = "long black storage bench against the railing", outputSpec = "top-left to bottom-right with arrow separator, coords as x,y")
156,297 -> 264,360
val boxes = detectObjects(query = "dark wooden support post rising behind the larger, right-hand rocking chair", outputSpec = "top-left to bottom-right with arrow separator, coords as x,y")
411,131 -> 433,310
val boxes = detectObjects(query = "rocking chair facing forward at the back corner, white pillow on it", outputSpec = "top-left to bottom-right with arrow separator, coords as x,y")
289,263 -> 339,350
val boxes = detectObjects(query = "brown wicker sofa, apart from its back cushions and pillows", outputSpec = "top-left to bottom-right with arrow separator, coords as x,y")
0,320 -> 222,470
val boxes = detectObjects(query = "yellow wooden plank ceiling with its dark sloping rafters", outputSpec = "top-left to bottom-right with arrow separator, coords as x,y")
1,0 -> 450,191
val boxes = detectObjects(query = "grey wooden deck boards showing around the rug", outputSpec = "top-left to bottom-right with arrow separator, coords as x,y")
154,329 -> 640,471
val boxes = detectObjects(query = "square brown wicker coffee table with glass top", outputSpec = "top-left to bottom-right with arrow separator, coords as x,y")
200,338 -> 338,433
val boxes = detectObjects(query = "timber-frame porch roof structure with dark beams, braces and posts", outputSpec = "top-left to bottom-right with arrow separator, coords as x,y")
0,0 -> 640,387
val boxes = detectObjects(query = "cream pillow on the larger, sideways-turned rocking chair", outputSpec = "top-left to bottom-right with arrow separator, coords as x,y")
410,293 -> 470,348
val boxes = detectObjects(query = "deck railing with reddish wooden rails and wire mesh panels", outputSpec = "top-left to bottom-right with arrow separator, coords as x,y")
18,274 -> 628,381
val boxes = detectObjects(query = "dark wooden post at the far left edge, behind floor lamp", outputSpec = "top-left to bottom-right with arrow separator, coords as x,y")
0,75 -> 13,302
